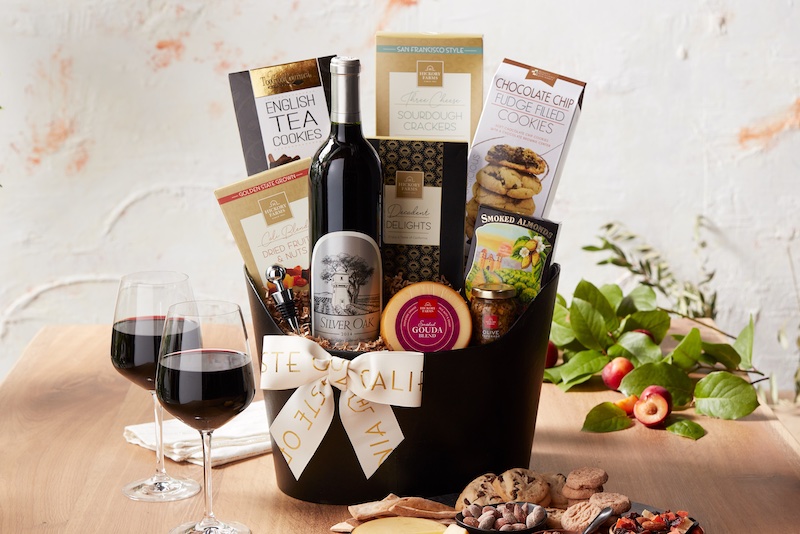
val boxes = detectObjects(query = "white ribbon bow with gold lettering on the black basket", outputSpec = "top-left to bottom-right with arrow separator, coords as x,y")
261,336 -> 424,479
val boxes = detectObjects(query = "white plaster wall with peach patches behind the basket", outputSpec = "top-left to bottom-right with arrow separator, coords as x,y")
0,0 -> 800,389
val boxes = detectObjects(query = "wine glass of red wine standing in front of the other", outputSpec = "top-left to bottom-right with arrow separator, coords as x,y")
156,300 -> 256,534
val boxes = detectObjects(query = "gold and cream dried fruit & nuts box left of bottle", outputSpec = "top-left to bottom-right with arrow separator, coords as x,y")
214,158 -> 311,297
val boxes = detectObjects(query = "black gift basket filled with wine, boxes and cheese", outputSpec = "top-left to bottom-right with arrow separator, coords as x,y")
215,32 -> 585,504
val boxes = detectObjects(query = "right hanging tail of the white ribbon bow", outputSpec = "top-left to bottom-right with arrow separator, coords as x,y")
339,391 -> 404,478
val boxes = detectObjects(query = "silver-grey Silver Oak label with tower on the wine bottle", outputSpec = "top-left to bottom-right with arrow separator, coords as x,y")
311,231 -> 383,343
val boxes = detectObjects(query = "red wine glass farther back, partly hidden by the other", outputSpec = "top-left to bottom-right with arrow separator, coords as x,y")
111,271 -> 200,502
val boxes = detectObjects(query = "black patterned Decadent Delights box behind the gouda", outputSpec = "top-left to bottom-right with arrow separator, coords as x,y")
369,137 -> 467,287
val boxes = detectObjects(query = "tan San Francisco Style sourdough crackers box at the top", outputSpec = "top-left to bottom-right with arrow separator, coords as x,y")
375,32 -> 483,143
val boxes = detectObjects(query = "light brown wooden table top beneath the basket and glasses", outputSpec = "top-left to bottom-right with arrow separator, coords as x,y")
0,325 -> 800,534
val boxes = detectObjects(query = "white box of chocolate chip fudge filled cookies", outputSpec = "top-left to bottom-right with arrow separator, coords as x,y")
466,59 -> 586,238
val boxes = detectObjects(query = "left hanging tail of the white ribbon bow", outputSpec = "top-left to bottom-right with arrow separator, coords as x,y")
269,379 -> 334,480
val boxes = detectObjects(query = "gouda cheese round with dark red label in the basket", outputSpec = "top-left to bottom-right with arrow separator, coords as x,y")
381,282 -> 472,352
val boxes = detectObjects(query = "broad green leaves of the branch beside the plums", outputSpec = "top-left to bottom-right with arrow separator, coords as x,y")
545,280 -> 760,439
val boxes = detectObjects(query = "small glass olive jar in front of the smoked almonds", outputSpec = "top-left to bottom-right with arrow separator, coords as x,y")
470,283 -> 518,345
